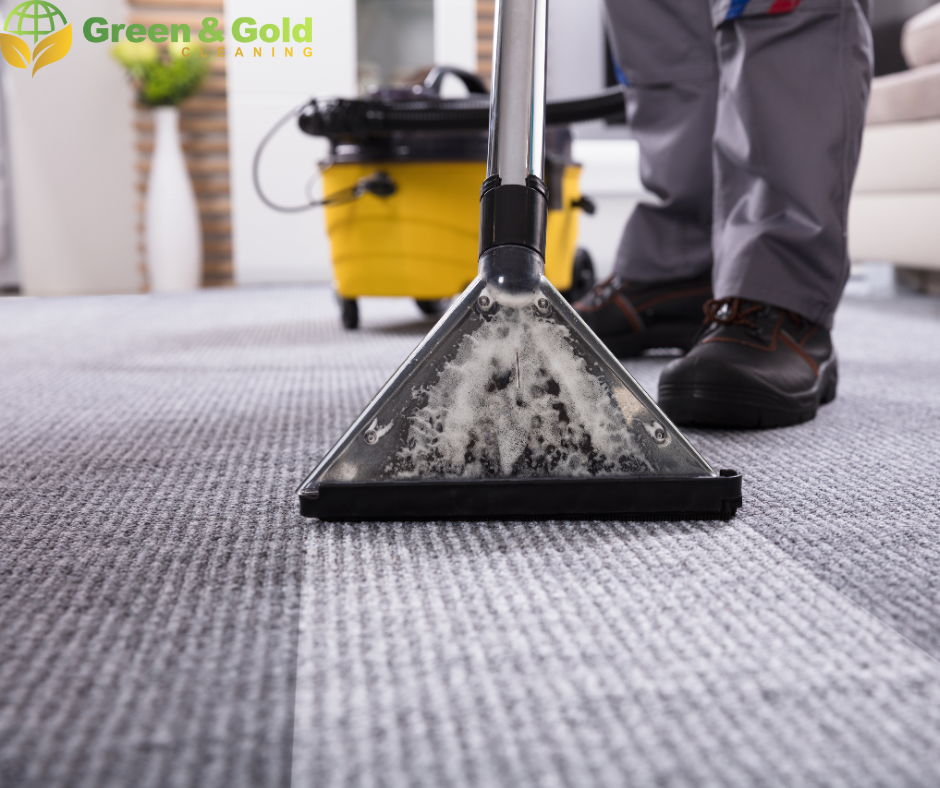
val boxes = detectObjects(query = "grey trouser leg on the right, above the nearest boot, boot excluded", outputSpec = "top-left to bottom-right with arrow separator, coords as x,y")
713,0 -> 872,328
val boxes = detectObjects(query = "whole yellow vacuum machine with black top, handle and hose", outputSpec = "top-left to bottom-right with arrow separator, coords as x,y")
276,67 -> 623,328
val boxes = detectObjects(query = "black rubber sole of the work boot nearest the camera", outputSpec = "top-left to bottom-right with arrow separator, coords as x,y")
658,353 -> 839,429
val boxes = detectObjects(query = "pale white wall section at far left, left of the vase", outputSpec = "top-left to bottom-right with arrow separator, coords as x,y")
2,0 -> 143,295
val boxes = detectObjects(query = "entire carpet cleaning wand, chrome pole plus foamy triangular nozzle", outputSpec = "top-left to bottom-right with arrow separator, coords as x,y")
297,0 -> 741,520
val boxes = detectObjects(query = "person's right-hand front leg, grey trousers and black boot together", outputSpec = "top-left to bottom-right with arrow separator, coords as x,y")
659,0 -> 872,427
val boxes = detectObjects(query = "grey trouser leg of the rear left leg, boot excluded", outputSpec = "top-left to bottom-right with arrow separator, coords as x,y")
606,0 -> 718,282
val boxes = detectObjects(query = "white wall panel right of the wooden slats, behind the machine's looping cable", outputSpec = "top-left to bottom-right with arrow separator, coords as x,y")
225,0 -> 356,284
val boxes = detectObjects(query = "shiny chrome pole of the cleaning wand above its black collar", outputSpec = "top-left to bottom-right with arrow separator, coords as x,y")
486,0 -> 548,185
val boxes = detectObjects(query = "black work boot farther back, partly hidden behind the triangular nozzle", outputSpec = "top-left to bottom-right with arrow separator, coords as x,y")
574,273 -> 712,358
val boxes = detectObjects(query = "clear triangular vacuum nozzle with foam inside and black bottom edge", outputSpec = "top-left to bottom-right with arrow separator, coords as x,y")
298,268 -> 741,520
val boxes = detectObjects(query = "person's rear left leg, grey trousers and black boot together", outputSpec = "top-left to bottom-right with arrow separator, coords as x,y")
575,0 -> 718,356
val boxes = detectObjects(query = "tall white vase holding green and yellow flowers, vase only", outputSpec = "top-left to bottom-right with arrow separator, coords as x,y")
145,107 -> 202,293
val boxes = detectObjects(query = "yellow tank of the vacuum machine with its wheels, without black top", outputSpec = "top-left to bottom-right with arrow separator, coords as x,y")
323,144 -> 594,328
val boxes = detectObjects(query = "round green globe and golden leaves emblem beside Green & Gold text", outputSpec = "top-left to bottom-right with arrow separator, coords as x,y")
0,0 -> 72,76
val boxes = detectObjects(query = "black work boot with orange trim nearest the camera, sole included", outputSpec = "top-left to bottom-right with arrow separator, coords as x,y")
659,298 -> 839,428
